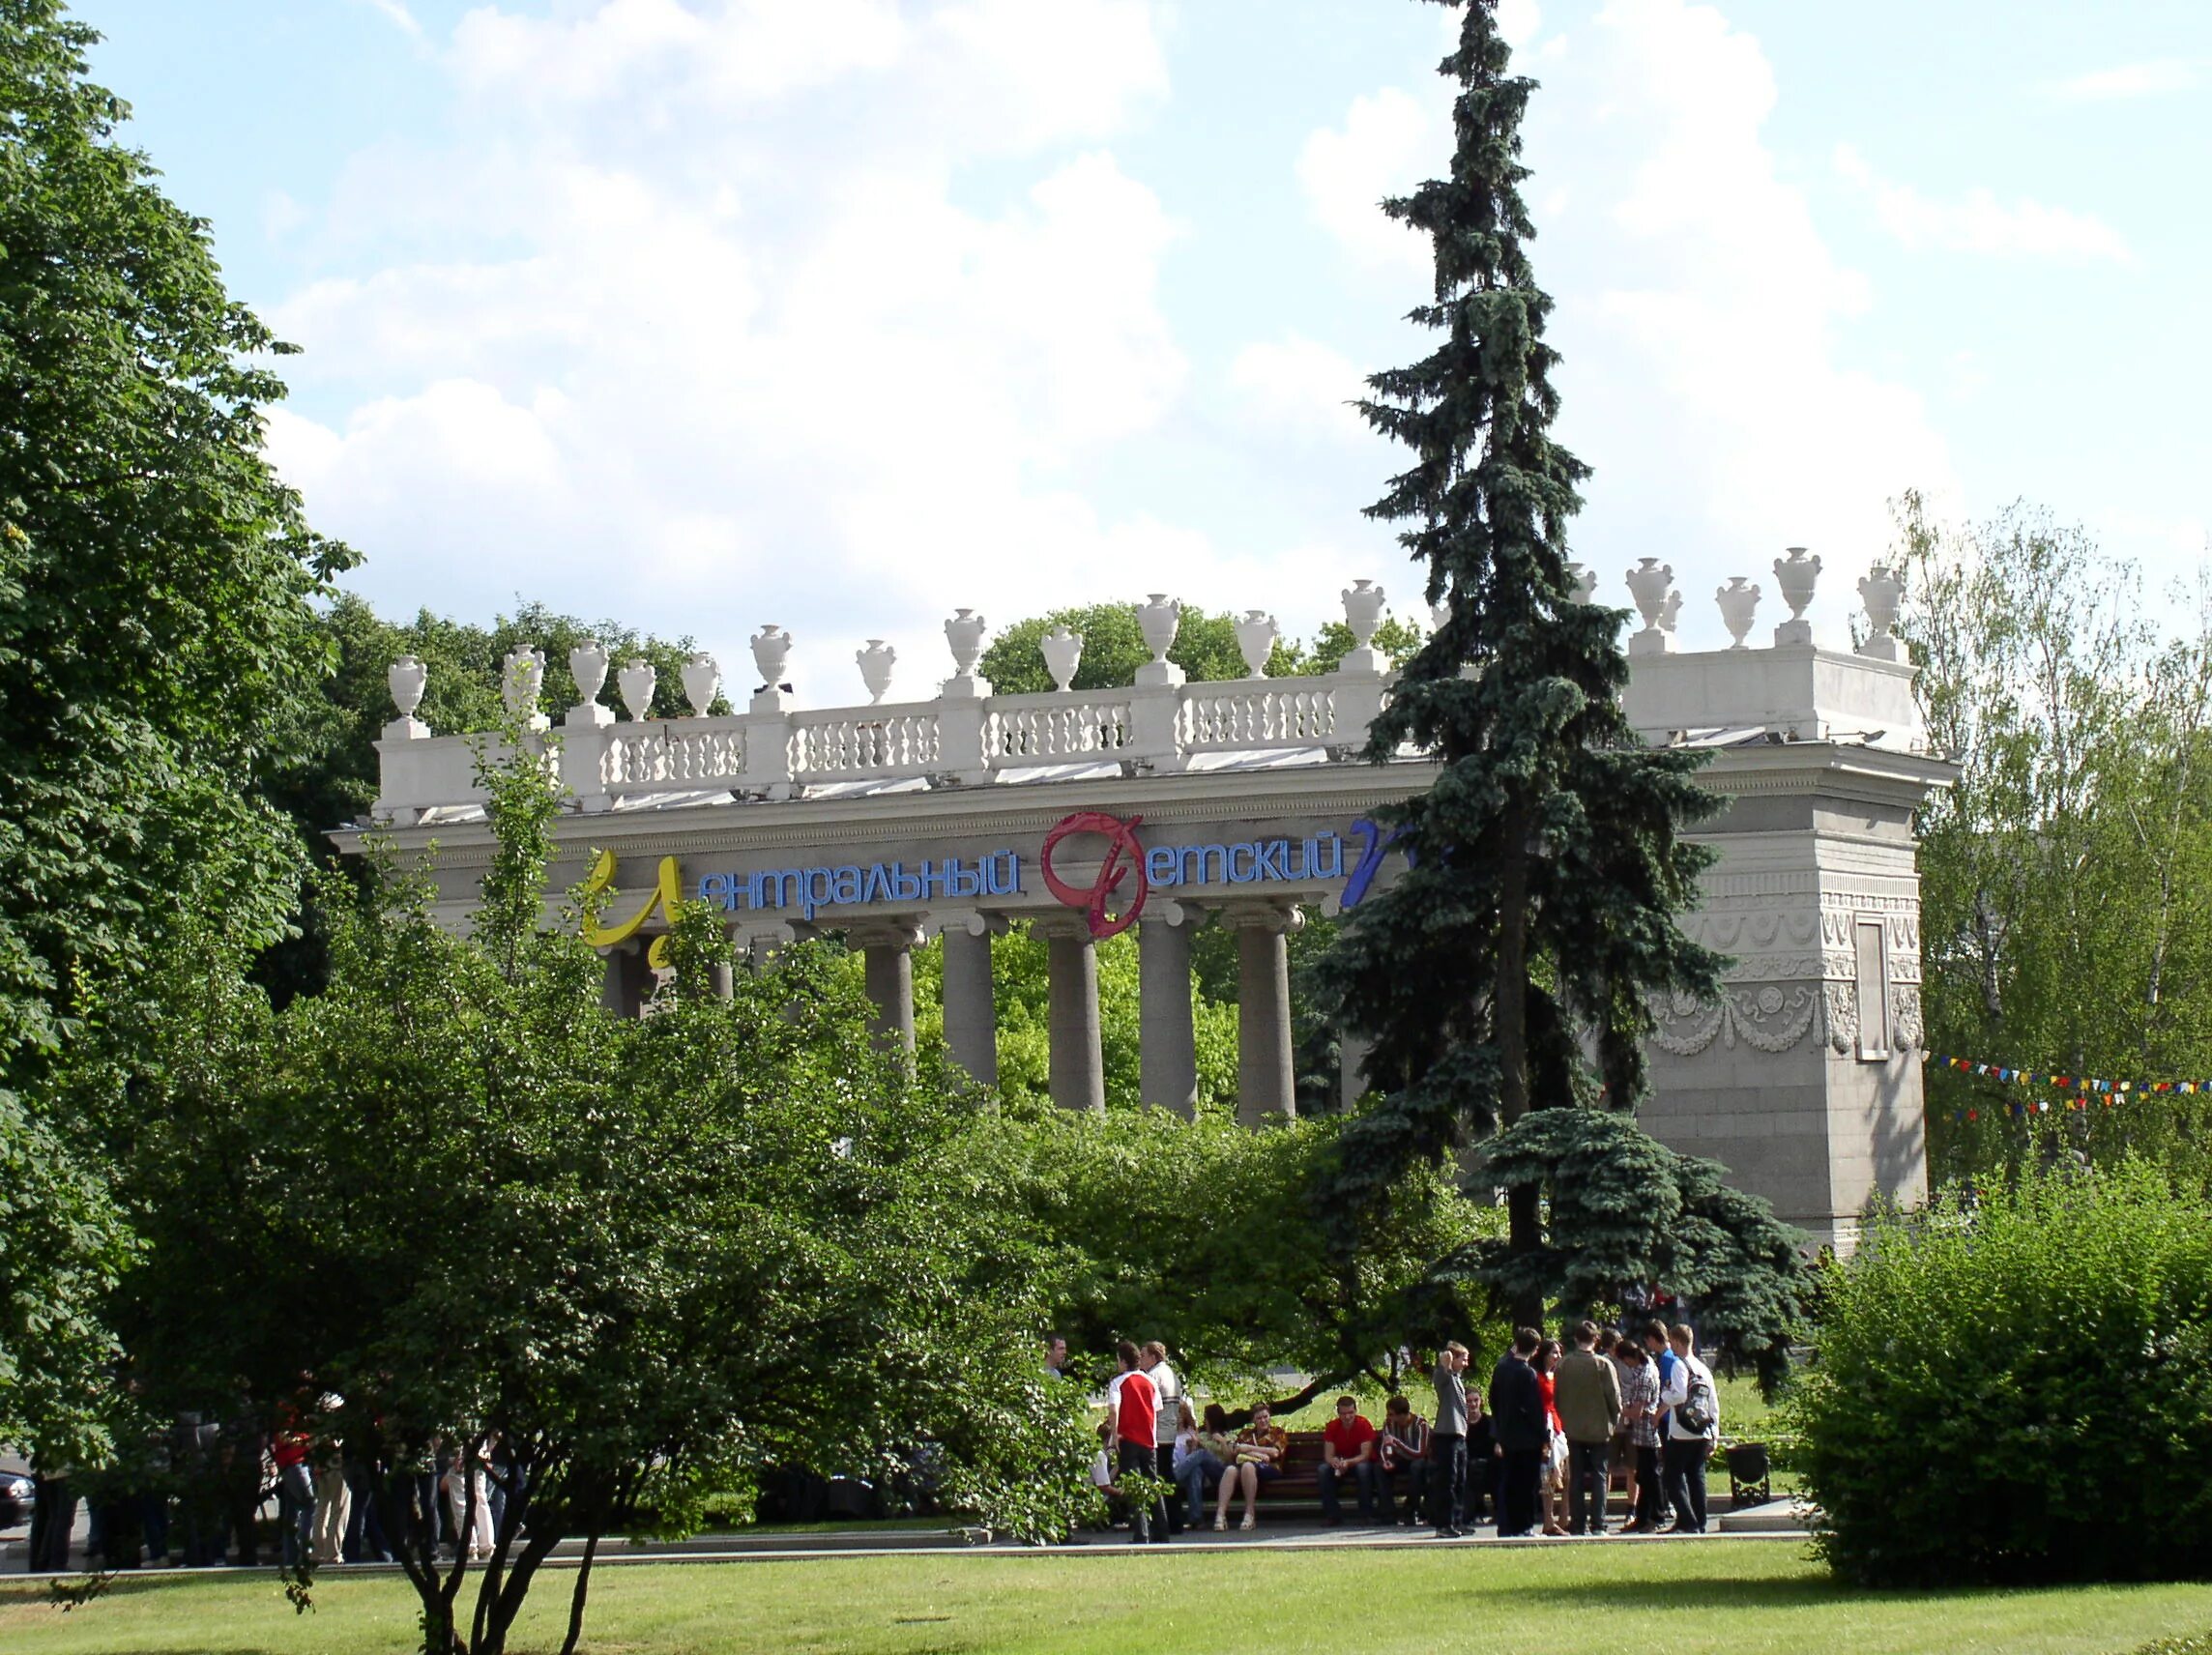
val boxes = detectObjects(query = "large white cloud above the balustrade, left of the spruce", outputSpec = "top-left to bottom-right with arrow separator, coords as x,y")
270,0 -> 1210,699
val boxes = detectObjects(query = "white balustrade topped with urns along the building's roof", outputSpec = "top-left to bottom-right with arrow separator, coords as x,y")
374,570 -> 1925,826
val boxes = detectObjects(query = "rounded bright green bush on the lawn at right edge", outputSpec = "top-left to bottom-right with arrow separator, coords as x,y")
1790,1164 -> 2212,1586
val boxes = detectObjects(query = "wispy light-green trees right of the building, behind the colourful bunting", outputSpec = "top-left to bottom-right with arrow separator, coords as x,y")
1898,496 -> 2212,1190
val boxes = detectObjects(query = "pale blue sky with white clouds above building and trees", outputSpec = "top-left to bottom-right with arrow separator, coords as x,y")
75,0 -> 2212,706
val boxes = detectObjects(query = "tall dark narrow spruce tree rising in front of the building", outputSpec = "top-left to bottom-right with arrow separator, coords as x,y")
1321,0 -> 1723,1321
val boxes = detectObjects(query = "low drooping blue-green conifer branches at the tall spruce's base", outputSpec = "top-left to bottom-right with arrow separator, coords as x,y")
1475,1109 -> 1814,1396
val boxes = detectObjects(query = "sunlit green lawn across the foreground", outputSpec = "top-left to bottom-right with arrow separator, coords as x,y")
0,1540 -> 2212,1655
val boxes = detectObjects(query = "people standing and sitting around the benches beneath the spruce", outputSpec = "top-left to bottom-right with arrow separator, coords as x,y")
1070,1319 -> 1721,1542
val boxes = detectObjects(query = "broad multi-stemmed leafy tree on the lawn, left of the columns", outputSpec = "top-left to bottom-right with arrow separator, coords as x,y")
95,730 -> 1089,1655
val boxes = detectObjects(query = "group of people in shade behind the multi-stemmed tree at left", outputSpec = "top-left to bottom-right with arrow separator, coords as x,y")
26,1389 -> 524,1573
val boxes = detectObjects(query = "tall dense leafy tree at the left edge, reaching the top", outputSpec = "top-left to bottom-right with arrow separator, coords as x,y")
0,0 -> 350,1454
